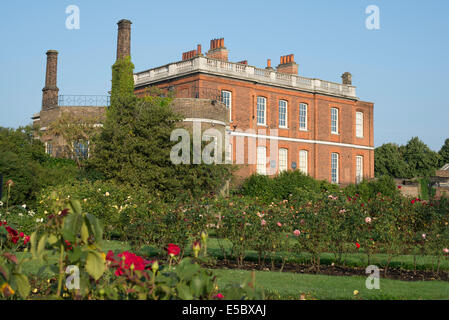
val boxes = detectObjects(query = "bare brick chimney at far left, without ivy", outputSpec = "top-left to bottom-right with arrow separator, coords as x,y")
42,50 -> 59,110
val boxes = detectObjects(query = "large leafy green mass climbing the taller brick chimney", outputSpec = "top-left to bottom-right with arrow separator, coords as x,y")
90,57 -> 233,197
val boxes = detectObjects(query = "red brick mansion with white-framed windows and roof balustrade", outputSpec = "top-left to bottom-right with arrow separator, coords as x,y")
134,39 -> 374,184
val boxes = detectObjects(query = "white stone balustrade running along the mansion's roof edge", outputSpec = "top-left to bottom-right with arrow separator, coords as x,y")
134,56 -> 357,98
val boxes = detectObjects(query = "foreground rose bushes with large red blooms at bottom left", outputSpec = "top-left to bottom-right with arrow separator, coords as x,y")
0,199 -> 264,300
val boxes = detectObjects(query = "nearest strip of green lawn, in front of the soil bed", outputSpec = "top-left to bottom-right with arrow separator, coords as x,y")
213,270 -> 449,300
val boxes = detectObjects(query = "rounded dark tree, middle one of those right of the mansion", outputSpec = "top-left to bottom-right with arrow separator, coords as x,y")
402,137 -> 440,177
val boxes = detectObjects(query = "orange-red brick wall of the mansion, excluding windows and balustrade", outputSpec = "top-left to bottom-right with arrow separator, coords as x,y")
136,74 -> 374,184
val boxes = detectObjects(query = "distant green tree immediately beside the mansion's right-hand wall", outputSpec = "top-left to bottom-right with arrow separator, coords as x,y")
374,143 -> 410,178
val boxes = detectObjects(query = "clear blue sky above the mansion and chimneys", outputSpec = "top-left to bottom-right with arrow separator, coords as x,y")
0,0 -> 449,151
